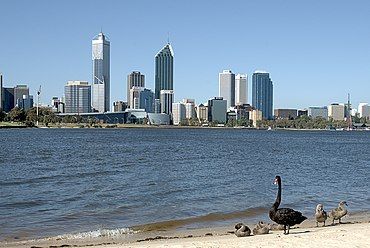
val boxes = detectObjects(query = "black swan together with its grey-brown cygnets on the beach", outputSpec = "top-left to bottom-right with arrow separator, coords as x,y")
234,176 -> 348,237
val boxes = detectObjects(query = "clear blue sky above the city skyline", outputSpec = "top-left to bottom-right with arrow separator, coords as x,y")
0,0 -> 370,108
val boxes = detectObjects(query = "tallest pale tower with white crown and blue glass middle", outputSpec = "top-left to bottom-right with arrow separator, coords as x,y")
91,32 -> 110,112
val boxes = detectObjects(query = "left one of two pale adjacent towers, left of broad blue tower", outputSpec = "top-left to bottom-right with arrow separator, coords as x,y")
218,70 -> 235,108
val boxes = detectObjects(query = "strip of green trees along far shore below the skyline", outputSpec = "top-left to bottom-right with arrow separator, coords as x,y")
0,107 -> 370,129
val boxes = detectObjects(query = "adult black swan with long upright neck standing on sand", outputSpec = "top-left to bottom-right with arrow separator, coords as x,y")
269,176 -> 307,234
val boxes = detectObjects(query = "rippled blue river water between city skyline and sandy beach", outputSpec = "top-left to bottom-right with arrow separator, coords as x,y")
0,129 -> 370,240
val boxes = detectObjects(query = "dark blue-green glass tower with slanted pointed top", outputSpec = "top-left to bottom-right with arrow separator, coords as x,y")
155,43 -> 174,99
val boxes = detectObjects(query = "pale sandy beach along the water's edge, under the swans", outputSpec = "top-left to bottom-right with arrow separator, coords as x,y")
0,212 -> 370,248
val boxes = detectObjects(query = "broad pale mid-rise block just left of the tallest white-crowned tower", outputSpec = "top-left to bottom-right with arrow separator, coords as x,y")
64,81 -> 91,114
